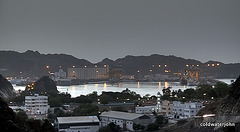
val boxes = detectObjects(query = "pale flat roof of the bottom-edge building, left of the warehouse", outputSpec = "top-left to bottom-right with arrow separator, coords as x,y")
57,116 -> 99,124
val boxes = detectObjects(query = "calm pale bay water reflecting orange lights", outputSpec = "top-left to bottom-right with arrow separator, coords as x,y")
13,79 -> 233,97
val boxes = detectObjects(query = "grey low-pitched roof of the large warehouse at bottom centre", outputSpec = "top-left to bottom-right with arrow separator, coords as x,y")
100,111 -> 144,120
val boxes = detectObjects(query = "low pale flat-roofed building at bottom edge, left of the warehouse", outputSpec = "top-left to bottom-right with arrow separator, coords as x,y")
56,116 -> 99,132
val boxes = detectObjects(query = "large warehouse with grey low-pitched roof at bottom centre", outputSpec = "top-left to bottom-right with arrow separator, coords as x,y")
100,111 -> 153,131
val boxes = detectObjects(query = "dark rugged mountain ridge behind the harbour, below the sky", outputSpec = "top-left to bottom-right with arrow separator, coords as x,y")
0,50 -> 240,78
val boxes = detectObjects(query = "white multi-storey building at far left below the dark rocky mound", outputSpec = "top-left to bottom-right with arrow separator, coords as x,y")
25,94 -> 49,115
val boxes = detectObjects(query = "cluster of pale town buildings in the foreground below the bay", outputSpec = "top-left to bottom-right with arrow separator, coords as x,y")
10,93 -> 203,132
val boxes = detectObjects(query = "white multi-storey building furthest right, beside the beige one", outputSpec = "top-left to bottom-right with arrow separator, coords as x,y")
173,101 -> 203,118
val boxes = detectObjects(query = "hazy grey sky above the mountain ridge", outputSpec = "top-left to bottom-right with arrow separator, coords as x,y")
0,0 -> 240,63
